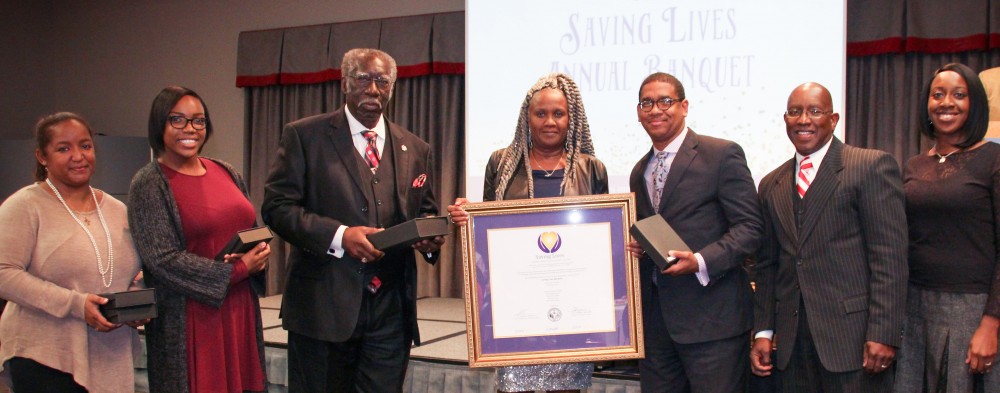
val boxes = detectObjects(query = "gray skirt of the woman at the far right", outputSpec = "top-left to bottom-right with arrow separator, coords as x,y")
893,285 -> 1000,393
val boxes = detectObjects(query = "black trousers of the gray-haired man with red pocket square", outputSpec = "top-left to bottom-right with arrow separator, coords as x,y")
288,280 -> 412,393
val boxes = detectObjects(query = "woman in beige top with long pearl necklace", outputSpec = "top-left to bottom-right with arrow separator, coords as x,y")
0,112 -> 139,393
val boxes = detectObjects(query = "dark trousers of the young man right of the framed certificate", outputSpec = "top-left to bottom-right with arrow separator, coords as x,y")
639,288 -> 750,393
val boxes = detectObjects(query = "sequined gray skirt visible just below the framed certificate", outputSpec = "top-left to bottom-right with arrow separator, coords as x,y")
497,363 -> 594,392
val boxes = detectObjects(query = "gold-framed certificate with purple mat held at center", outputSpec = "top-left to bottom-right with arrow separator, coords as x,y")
461,194 -> 644,367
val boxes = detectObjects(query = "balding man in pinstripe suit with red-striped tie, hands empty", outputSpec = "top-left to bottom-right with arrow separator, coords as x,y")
751,83 -> 908,392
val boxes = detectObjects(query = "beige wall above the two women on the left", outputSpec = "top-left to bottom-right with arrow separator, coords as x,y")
0,0 -> 465,168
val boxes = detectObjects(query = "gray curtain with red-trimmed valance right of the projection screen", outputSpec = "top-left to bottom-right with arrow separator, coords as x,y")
844,0 -> 1000,164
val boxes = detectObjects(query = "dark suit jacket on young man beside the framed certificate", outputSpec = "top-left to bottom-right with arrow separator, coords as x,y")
629,129 -> 762,344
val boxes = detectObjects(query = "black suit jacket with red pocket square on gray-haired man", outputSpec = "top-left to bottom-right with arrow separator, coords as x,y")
261,108 -> 437,344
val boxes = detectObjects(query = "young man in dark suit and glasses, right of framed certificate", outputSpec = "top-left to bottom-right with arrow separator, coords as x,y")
629,73 -> 762,393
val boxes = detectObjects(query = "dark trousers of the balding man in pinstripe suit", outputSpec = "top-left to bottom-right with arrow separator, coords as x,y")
784,304 -> 896,393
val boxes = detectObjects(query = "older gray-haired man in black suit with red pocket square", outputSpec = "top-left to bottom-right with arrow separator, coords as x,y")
261,49 -> 444,392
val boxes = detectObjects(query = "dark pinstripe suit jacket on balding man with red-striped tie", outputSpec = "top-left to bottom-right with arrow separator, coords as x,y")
755,138 -> 909,372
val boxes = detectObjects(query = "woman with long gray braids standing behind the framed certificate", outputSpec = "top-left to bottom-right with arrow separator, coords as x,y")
448,73 -> 608,392
